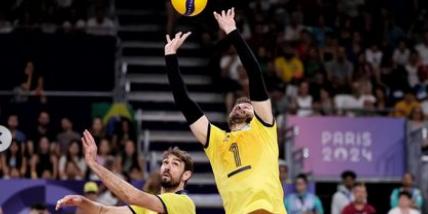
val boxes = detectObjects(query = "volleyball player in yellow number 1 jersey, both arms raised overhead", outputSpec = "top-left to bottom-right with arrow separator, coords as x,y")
165,8 -> 286,214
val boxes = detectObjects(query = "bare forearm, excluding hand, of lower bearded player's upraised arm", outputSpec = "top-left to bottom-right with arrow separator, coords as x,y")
88,162 -> 149,206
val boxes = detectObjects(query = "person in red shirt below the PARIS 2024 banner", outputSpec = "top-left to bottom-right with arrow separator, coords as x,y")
342,183 -> 376,214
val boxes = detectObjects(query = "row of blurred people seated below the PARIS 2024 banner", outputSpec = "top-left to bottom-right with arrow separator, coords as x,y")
280,169 -> 426,214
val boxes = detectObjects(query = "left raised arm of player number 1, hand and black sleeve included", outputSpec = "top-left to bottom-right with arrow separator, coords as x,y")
165,32 -> 210,145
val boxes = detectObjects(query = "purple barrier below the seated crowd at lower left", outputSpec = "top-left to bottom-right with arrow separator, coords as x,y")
0,179 -> 144,214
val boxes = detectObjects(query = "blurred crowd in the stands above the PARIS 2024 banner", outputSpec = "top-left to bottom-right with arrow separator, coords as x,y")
219,0 -> 428,123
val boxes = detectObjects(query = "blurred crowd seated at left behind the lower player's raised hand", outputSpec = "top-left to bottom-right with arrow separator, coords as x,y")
0,111 -> 144,180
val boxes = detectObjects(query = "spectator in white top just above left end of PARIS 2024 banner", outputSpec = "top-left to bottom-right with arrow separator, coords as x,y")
294,82 -> 313,117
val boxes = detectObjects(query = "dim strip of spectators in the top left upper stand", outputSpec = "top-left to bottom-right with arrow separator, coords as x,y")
0,0 -> 116,35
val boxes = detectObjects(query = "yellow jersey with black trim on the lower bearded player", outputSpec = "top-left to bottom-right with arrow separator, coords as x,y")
129,191 -> 196,214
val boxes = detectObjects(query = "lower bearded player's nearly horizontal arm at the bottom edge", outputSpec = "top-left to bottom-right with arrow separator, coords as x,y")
55,195 -> 132,214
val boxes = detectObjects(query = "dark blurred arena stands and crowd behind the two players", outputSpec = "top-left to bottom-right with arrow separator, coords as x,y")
0,0 -> 428,214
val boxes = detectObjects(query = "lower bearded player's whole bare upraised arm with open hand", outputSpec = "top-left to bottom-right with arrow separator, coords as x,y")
82,130 -> 166,213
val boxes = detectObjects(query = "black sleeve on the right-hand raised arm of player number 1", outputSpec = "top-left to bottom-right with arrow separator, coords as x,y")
227,30 -> 269,101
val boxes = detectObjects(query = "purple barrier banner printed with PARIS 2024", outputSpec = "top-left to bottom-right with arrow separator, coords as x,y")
288,117 -> 406,180
